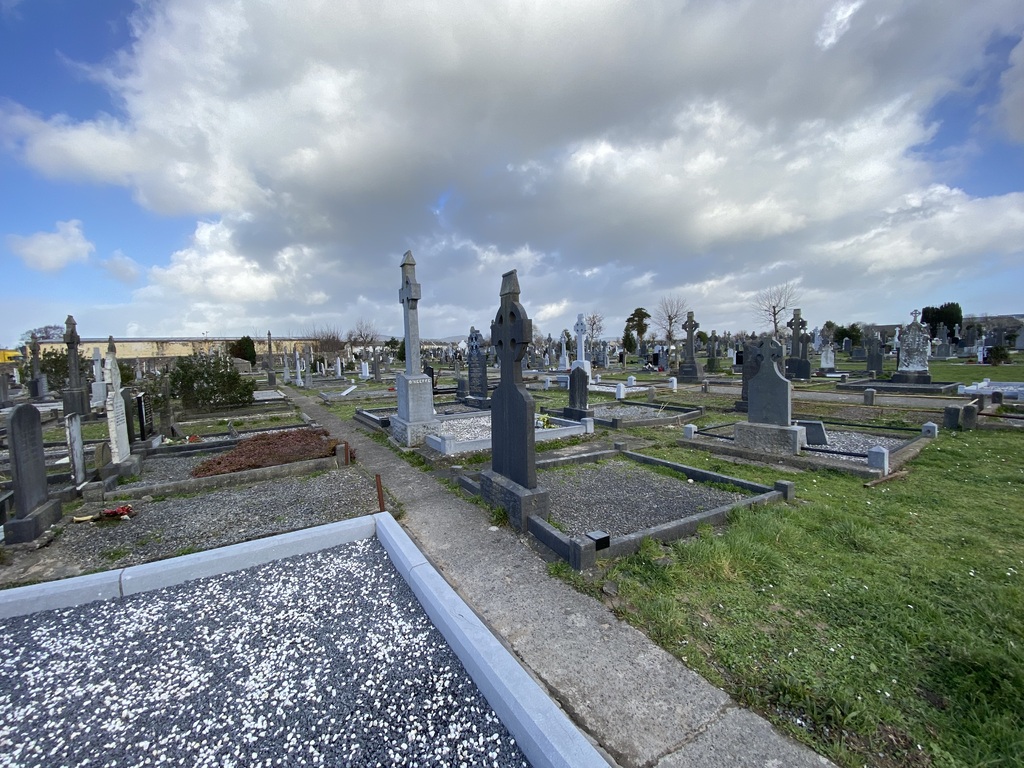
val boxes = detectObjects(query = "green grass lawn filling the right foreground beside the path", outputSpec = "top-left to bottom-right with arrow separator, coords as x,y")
585,432 -> 1024,767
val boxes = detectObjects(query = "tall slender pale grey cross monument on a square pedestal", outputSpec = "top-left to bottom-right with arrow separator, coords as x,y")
391,251 -> 436,447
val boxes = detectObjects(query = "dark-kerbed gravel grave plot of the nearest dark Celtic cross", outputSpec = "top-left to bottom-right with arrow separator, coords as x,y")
528,451 -> 778,569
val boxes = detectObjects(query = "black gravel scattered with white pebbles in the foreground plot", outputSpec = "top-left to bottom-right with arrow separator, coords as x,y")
0,540 -> 528,768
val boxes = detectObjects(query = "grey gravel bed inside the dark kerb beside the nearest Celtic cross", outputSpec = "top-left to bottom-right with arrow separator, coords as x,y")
538,459 -> 749,537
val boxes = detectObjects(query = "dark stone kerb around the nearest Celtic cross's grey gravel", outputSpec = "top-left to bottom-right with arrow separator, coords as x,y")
468,447 -> 795,570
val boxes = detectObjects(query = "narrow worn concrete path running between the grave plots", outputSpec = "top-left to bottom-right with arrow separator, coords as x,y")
288,388 -> 833,768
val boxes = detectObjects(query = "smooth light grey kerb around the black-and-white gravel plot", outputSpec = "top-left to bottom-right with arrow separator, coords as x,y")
0,512 -> 605,768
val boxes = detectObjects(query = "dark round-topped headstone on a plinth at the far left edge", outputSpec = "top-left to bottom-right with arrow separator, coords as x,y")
3,403 -> 60,544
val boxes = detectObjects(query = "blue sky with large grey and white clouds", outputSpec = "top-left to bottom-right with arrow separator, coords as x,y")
0,0 -> 1024,345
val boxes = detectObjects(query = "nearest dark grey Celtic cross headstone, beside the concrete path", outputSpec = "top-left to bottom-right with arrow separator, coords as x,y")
480,269 -> 548,530
